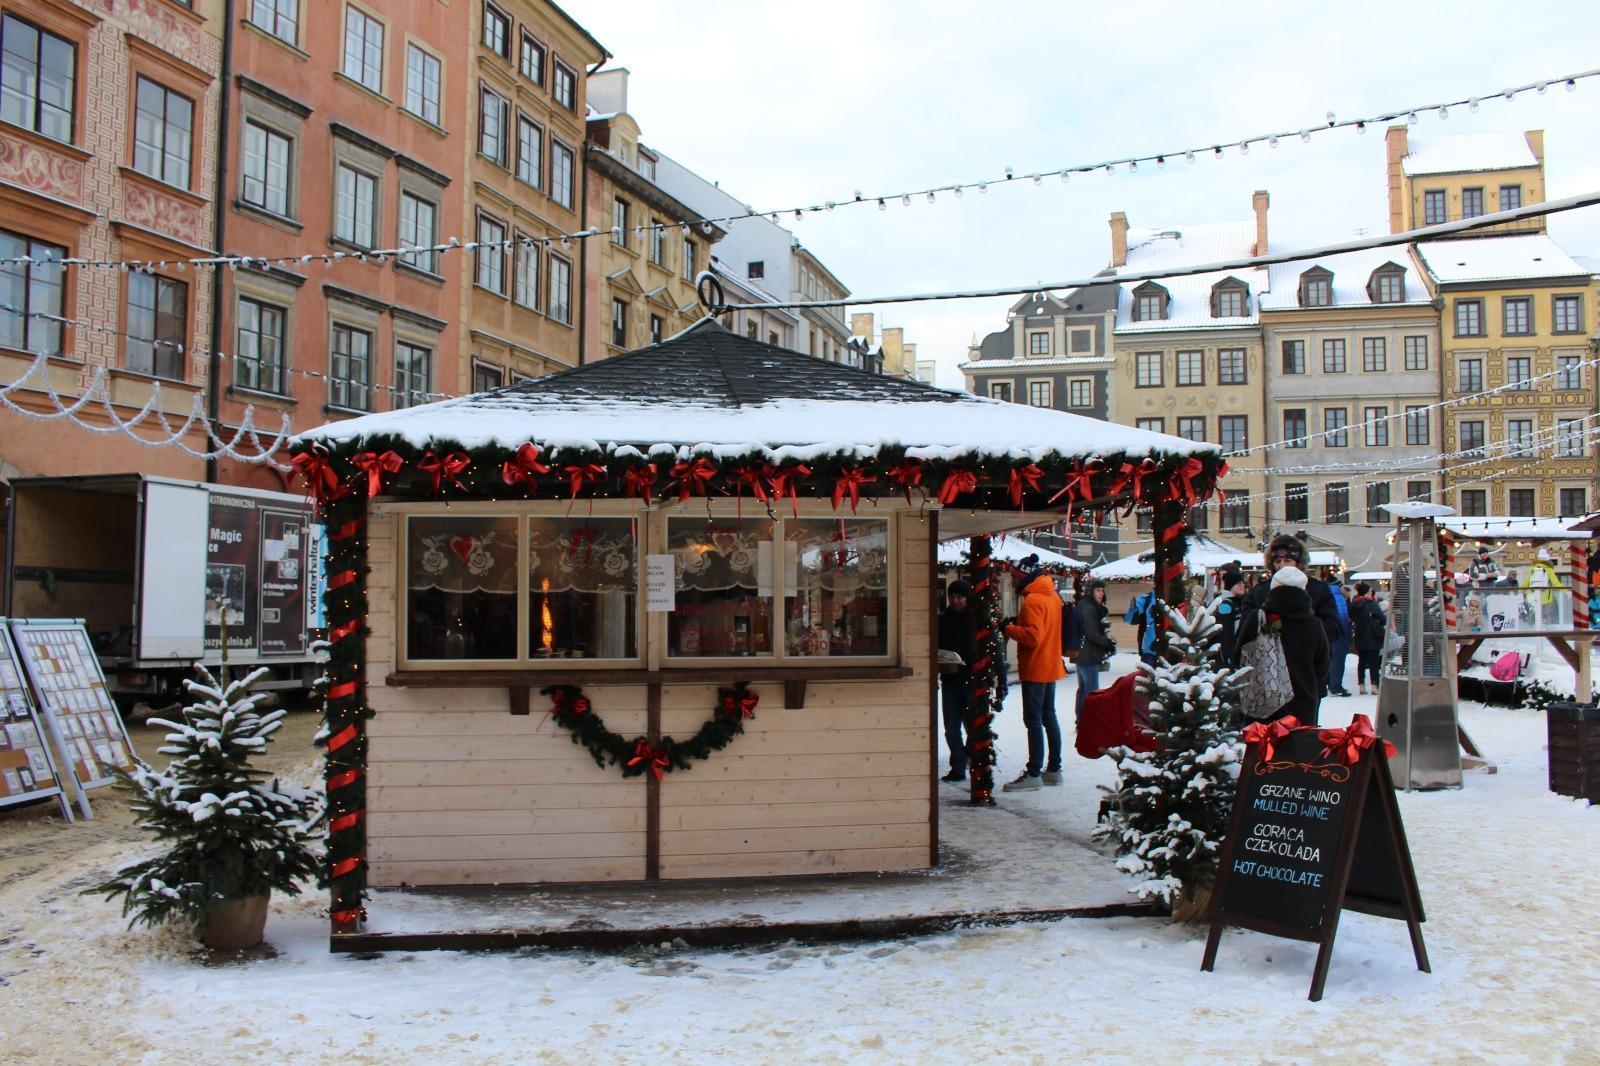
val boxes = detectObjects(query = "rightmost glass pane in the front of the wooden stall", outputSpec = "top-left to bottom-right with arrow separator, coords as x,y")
784,519 -> 890,656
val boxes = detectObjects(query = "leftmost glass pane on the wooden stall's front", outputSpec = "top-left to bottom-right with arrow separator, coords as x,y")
406,515 -> 517,659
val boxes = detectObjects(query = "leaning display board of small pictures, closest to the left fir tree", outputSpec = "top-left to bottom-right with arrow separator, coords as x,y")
11,618 -> 134,818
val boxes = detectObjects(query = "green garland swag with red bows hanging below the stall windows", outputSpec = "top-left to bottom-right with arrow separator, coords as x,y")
539,682 -> 760,781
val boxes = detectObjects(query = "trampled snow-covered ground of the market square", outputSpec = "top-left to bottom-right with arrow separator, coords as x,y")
0,658 -> 1600,1063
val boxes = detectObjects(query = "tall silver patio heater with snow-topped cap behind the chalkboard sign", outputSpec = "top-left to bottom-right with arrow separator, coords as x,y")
1378,503 -> 1461,791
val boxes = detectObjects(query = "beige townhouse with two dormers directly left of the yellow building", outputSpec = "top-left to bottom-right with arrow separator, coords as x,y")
1261,248 -> 1443,570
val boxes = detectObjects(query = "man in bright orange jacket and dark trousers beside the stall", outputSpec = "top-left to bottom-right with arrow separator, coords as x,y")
1005,555 -> 1067,792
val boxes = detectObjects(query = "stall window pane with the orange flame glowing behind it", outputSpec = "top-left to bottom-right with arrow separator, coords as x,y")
528,519 -> 638,659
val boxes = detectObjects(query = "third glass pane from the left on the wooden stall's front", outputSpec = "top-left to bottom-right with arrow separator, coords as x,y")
667,507 -> 773,656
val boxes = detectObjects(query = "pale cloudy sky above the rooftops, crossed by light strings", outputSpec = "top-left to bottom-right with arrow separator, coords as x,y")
563,0 -> 1600,387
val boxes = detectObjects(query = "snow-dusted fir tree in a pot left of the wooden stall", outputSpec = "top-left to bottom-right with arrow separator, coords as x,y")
88,667 -> 322,935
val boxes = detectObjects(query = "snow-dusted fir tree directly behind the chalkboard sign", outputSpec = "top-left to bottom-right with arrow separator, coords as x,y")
1094,607 -> 1248,917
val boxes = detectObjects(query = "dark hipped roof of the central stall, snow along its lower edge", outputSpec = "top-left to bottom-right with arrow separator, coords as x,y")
298,319 -> 1218,463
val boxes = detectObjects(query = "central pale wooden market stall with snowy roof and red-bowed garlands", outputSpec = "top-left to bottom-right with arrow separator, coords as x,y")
294,319 -> 1222,940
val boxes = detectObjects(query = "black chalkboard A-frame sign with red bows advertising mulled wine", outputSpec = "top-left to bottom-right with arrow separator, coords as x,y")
1200,715 -> 1430,1000
